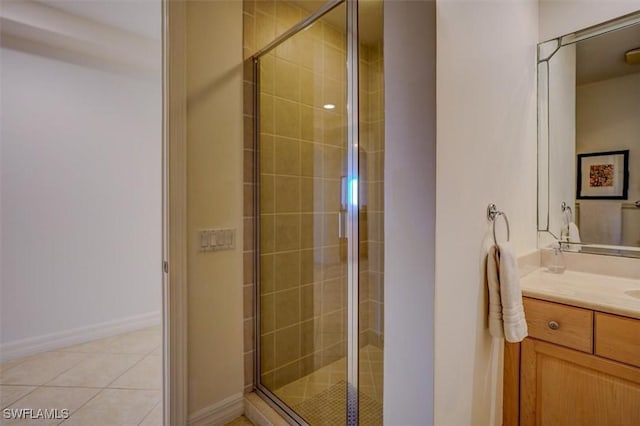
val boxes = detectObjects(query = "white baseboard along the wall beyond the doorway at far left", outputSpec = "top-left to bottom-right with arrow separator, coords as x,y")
0,312 -> 162,361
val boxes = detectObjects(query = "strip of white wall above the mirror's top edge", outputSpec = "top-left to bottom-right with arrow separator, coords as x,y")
538,0 -> 640,41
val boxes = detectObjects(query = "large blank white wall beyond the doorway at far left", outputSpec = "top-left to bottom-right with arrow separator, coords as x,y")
0,2 -> 162,356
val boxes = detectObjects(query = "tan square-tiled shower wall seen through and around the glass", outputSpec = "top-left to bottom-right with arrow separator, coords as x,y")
244,1 -> 384,391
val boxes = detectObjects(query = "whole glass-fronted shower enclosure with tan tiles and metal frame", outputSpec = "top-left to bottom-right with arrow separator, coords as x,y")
253,0 -> 384,425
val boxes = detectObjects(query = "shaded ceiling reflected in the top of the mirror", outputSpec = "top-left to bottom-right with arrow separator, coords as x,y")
576,24 -> 640,85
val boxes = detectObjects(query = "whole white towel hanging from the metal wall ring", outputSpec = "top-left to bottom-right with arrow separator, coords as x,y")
487,243 -> 528,343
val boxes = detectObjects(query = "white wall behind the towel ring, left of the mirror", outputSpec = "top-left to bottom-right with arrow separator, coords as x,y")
435,0 -> 538,426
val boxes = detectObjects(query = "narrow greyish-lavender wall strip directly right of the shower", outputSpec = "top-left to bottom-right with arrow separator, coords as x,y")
384,1 -> 436,426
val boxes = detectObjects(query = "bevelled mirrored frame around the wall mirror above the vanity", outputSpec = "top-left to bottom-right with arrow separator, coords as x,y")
536,10 -> 640,258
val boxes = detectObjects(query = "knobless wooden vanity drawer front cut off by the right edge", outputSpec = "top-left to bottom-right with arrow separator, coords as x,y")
595,312 -> 640,367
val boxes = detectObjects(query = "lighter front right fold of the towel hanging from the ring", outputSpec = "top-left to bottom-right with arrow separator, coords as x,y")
496,243 -> 528,343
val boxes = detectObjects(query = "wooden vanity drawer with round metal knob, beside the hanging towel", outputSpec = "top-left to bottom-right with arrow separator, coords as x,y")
523,297 -> 593,353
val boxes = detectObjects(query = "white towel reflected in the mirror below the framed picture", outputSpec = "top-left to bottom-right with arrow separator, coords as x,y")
580,200 -> 622,245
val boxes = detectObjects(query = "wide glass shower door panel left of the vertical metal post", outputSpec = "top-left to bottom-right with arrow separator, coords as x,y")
257,3 -> 350,424
